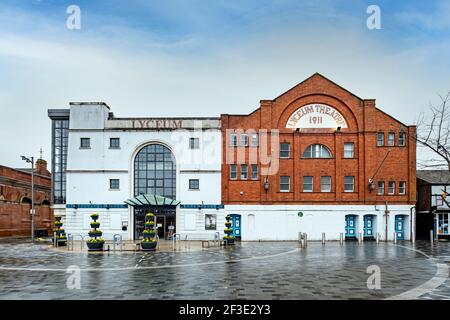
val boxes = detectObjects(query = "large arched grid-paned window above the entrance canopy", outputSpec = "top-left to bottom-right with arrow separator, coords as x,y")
134,144 -> 176,200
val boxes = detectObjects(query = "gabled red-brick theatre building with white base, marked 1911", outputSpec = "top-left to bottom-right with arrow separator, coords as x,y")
221,74 -> 416,240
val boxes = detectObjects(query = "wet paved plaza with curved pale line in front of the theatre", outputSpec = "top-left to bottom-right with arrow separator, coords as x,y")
0,239 -> 450,299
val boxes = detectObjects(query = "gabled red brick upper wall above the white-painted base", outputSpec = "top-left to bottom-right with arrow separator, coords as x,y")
221,74 -> 416,204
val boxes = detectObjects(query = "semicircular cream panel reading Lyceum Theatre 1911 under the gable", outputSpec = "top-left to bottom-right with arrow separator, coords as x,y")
286,104 -> 347,129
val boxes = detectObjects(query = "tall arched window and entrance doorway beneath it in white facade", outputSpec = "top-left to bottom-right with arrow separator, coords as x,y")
133,143 -> 176,240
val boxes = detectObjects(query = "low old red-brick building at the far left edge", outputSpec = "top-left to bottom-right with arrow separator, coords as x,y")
0,159 -> 53,237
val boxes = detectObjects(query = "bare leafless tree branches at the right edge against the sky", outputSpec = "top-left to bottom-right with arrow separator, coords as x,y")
416,91 -> 450,171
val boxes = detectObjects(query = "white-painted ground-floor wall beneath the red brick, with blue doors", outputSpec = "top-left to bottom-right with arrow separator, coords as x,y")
225,205 -> 410,241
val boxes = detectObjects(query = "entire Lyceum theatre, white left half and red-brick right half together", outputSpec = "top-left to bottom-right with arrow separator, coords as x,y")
48,74 -> 416,241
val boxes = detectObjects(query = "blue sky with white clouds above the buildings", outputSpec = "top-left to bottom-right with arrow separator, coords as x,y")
0,0 -> 450,167
